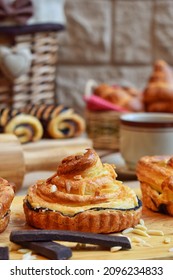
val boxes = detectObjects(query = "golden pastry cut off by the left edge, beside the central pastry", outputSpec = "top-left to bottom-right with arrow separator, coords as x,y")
0,177 -> 14,233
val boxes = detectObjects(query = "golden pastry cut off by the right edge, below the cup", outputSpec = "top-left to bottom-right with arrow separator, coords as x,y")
136,156 -> 173,216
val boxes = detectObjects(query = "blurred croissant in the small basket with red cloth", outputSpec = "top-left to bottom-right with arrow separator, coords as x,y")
93,84 -> 143,112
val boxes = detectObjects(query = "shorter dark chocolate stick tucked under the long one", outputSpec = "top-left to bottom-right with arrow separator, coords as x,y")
17,241 -> 72,260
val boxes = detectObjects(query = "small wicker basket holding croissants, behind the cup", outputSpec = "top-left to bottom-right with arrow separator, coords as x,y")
85,109 -> 121,150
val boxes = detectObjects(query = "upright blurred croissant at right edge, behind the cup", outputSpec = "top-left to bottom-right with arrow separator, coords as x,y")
143,60 -> 173,112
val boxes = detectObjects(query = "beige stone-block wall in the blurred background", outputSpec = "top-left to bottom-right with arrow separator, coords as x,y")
57,0 -> 173,114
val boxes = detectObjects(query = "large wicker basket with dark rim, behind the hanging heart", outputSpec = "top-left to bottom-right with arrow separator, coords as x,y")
0,24 -> 64,108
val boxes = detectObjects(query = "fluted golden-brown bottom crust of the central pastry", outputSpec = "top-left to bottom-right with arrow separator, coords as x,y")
24,201 -> 142,233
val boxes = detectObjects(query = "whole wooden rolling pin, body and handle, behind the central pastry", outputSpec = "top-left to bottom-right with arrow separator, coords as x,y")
0,134 -> 92,191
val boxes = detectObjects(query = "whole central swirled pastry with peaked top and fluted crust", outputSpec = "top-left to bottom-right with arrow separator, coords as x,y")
24,149 -> 142,233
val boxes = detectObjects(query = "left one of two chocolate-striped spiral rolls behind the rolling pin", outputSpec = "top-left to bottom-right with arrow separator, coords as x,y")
0,108 -> 43,143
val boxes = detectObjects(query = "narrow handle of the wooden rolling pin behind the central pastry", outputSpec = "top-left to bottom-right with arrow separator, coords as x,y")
23,138 -> 92,172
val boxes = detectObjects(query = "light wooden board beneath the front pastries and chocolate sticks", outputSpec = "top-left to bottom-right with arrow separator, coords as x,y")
0,192 -> 173,260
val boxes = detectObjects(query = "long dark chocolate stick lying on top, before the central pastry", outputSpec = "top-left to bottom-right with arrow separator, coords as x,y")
10,229 -> 131,249
